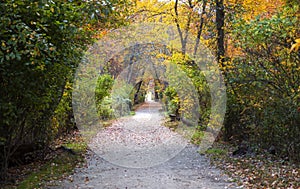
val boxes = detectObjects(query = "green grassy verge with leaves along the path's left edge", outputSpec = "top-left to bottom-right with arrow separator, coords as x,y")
3,131 -> 87,189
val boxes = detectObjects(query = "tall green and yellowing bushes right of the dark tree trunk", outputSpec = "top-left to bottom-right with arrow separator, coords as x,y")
226,6 -> 300,160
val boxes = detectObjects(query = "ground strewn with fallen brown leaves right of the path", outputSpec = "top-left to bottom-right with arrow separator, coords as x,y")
206,142 -> 300,189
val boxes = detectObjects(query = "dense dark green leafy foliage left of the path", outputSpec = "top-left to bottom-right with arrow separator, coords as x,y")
0,0 -> 122,177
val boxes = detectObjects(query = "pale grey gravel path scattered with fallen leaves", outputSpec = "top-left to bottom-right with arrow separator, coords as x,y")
51,102 -> 235,189
